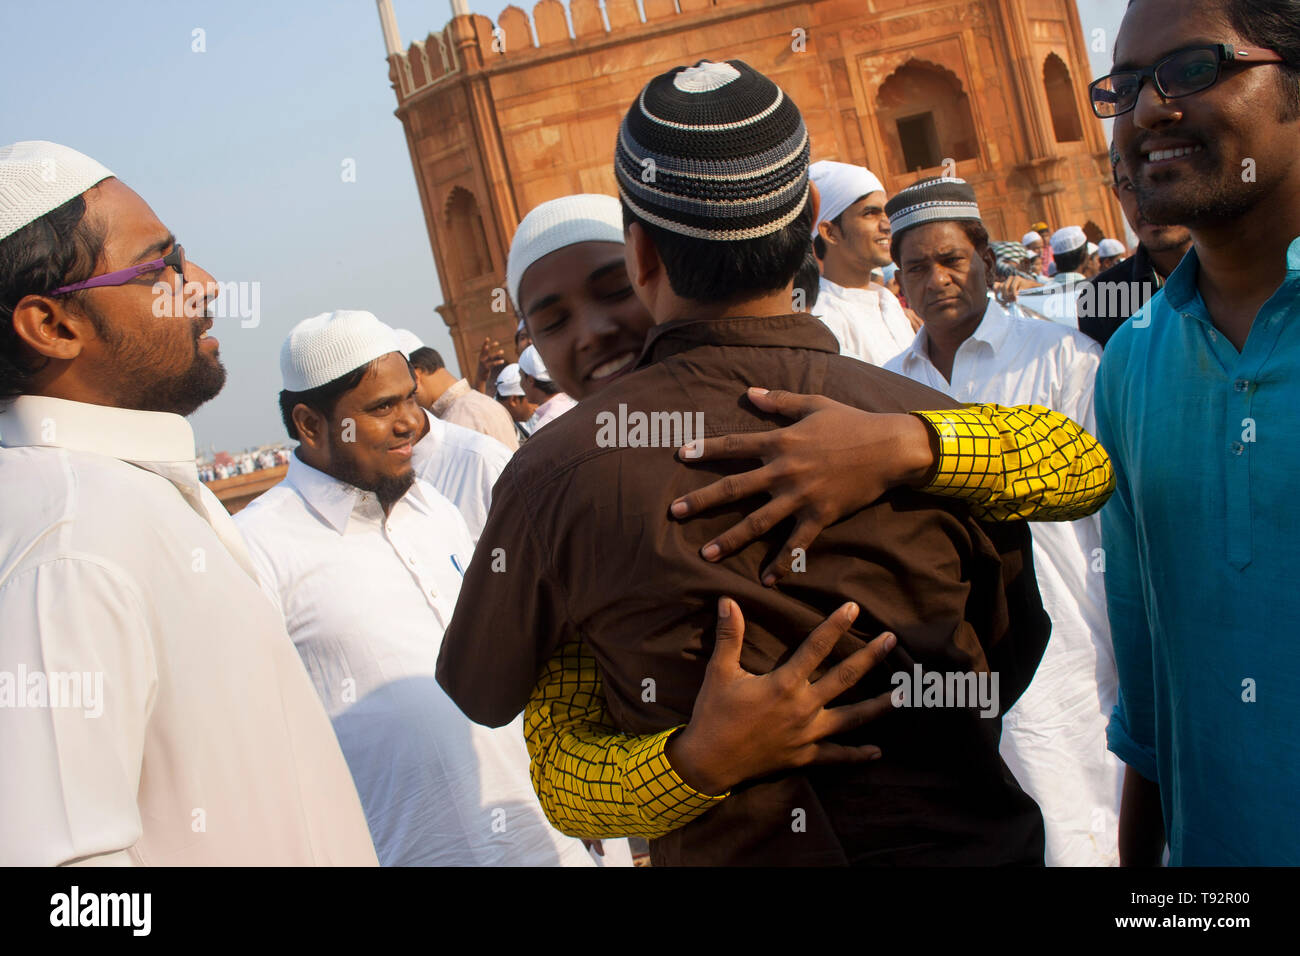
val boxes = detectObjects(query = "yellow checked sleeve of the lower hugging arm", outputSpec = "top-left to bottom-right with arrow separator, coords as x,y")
524,639 -> 727,840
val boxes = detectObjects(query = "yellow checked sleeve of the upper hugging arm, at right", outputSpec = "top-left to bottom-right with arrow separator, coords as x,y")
915,405 -> 1115,522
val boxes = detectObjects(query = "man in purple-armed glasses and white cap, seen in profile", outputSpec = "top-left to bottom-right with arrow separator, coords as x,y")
0,142 -> 376,866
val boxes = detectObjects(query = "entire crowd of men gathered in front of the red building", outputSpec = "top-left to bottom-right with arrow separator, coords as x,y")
0,0 -> 1300,866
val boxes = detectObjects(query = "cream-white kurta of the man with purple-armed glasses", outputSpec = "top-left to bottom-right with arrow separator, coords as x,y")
0,395 -> 376,866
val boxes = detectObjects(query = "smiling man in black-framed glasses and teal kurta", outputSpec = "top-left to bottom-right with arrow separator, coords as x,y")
1092,0 -> 1300,866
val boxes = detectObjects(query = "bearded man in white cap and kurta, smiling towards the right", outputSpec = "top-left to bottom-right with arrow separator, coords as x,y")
237,311 -> 592,866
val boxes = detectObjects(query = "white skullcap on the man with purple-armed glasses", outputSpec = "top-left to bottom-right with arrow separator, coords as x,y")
0,139 -> 113,239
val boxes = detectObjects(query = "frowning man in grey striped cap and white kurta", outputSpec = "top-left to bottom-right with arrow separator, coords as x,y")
885,179 -> 1122,866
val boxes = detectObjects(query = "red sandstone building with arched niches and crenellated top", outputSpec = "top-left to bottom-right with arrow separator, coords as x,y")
389,0 -> 1125,372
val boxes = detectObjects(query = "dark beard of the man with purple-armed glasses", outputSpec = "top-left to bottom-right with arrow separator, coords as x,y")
90,303 -> 226,416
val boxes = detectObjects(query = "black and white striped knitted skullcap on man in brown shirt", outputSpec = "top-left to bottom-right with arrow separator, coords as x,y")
614,60 -> 809,242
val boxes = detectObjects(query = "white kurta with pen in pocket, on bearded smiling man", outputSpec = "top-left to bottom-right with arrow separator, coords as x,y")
237,454 -> 592,866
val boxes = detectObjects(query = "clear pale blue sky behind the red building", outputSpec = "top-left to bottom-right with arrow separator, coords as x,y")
0,0 -> 1125,450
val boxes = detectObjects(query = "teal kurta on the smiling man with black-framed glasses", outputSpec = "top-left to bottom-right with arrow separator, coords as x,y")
1096,238 -> 1300,865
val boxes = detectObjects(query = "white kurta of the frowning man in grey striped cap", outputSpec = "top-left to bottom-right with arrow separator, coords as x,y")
887,299 -> 1122,866
